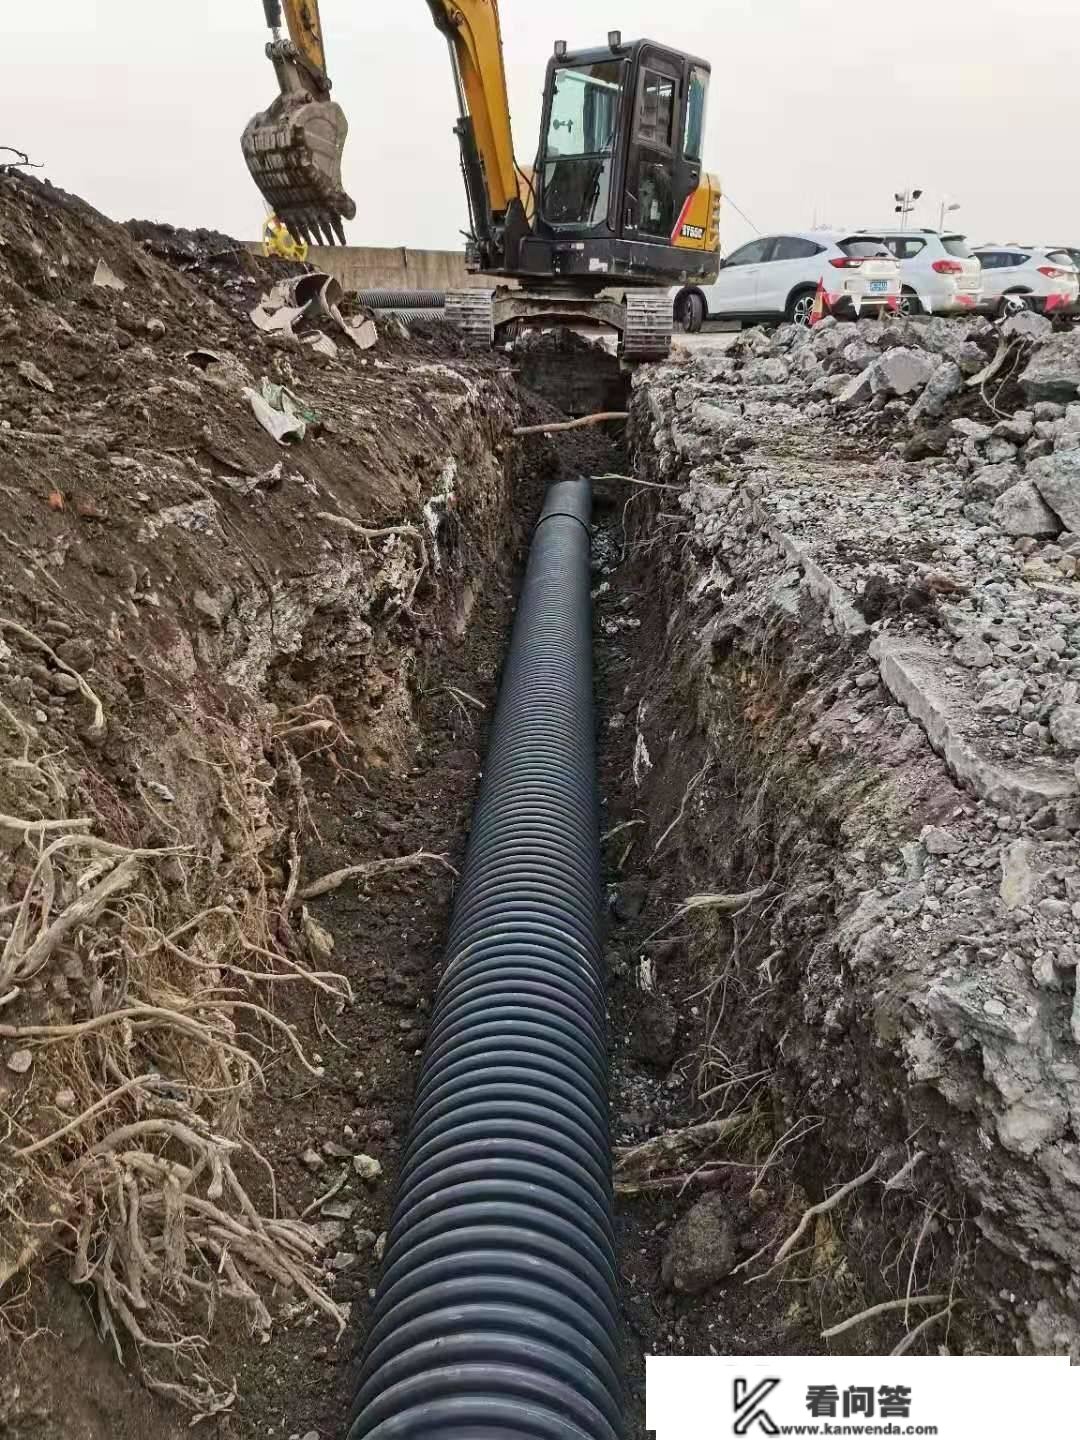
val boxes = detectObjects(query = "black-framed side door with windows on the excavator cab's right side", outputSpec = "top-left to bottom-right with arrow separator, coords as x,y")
624,49 -> 707,245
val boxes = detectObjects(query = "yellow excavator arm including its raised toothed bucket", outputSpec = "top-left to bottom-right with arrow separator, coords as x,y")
242,0 -> 527,256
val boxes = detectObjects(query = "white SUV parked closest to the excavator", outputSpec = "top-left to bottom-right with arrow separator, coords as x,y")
672,230 -> 901,331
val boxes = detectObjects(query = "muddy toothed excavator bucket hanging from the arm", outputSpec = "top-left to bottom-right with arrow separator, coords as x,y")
240,94 -> 356,245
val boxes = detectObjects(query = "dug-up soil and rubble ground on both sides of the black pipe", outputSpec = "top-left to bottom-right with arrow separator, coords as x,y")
0,157 -> 1080,1440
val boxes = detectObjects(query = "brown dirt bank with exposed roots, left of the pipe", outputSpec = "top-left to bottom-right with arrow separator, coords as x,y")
0,168 -> 524,1434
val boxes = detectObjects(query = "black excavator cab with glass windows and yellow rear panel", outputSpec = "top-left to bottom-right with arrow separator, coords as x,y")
520,33 -> 720,288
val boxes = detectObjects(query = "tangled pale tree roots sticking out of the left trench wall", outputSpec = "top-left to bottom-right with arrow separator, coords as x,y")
0,702 -> 351,1417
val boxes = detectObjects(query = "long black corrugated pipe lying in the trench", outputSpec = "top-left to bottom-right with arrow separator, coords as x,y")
348,481 -> 622,1440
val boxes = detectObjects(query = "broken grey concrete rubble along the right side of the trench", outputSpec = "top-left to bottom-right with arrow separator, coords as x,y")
634,315 -> 1080,1356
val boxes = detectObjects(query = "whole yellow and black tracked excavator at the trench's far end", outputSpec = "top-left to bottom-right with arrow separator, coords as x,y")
242,0 -> 720,360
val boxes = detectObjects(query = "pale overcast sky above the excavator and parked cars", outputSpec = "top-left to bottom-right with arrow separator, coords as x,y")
8,0 -> 1080,251
